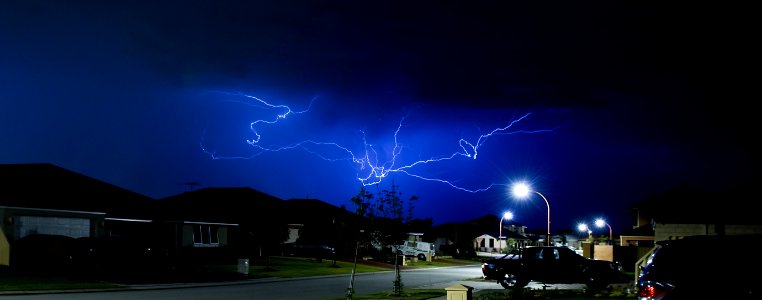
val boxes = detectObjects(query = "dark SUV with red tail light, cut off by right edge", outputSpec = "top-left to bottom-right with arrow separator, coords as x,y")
637,235 -> 762,300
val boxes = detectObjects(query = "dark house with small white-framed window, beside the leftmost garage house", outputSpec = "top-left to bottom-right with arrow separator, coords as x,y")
157,187 -> 288,262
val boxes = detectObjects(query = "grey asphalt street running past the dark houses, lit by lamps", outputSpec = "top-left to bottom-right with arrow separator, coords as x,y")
0,265 -> 492,300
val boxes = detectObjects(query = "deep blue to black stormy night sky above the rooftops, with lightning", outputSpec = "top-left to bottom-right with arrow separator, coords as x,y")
0,0 -> 762,236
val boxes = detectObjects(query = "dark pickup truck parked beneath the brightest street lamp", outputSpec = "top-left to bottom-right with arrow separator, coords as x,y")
482,246 -> 625,289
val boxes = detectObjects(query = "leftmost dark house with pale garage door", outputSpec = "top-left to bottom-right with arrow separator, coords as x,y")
0,164 -> 152,266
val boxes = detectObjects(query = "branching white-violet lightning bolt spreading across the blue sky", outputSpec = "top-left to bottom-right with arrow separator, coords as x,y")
201,94 -> 554,193
